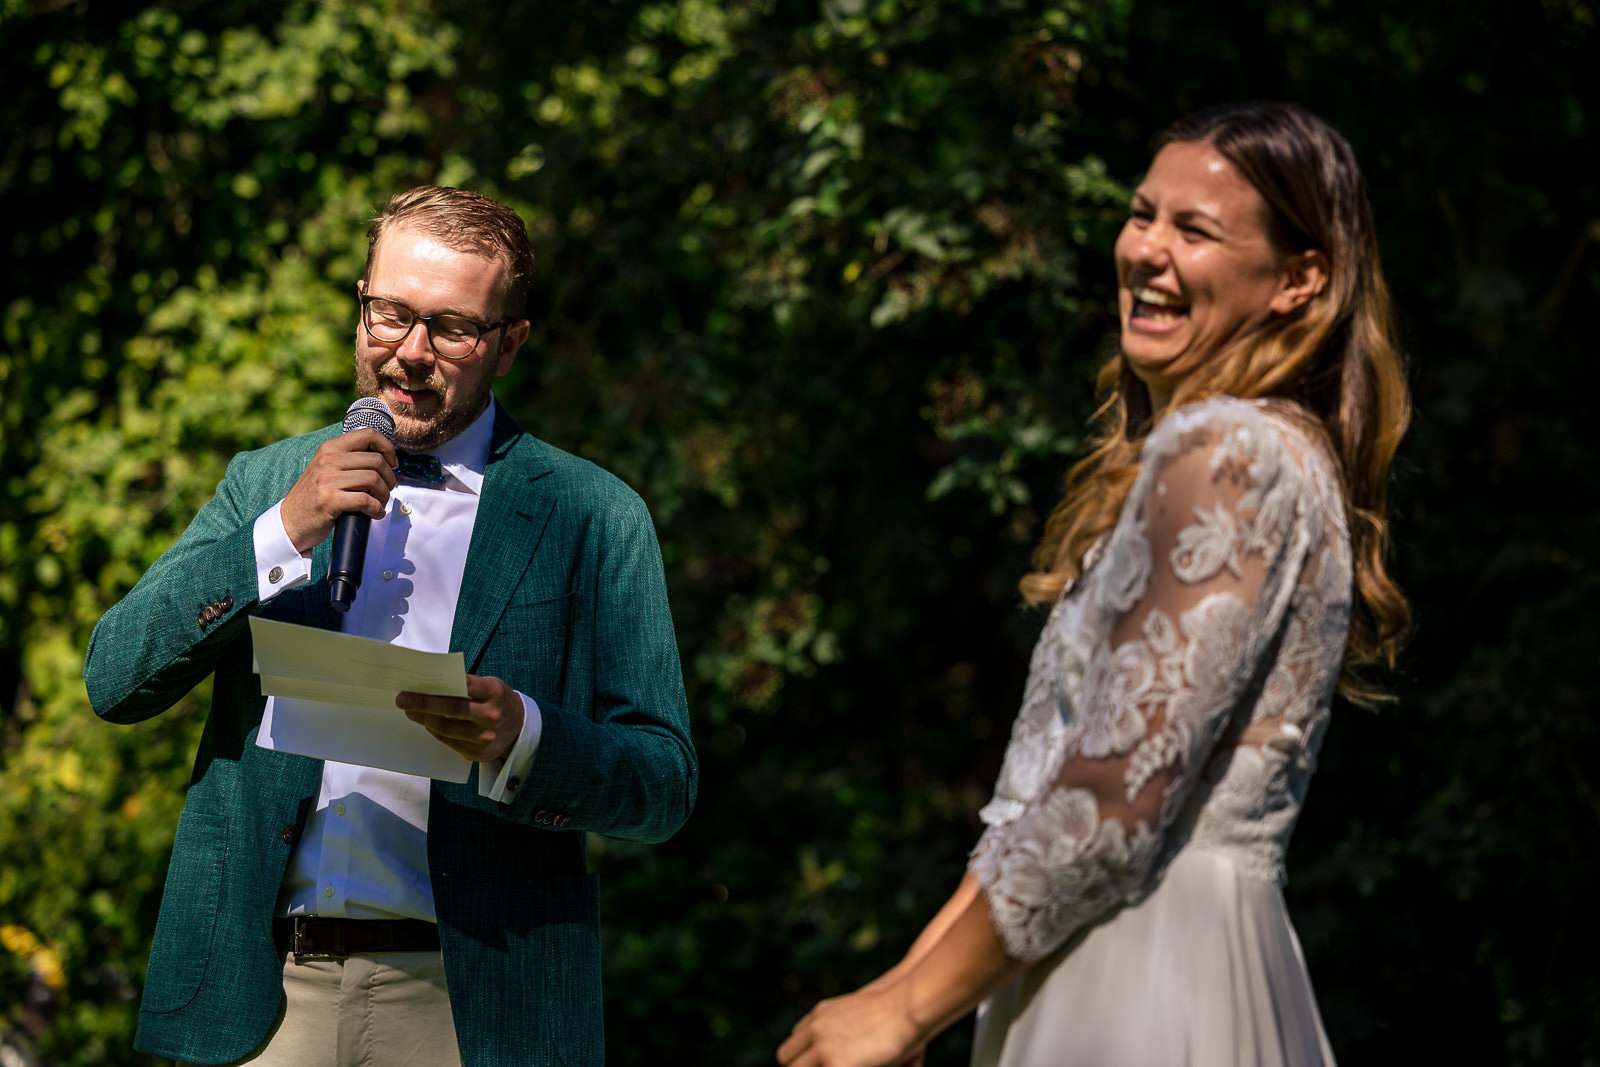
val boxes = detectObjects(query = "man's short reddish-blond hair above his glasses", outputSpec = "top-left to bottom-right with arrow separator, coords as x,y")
366,186 -> 533,318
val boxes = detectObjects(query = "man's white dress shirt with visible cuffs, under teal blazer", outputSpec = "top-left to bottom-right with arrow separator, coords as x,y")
254,400 -> 542,921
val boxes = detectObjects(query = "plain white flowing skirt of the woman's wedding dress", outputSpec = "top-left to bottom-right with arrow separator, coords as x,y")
973,848 -> 1333,1067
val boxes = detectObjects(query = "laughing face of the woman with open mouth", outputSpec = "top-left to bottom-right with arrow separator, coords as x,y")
1117,141 -> 1304,405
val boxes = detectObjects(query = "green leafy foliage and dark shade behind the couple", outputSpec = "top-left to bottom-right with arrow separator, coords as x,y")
0,0 -> 1600,1064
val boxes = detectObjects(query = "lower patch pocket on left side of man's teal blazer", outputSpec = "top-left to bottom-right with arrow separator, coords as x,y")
142,811 -> 227,1013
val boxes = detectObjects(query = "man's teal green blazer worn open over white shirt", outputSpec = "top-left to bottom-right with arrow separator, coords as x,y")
83,404 -> 698,1067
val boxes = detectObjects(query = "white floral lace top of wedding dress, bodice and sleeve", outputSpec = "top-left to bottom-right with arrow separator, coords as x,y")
971,398 -> 1350,960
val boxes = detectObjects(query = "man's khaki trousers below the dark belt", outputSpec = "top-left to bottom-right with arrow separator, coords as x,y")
188,952 -> 461,1067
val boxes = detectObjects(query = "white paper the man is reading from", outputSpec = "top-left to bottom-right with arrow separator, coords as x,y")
250,617 -> 472,782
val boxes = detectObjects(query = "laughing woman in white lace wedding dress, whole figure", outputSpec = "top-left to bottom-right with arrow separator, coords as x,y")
778,104 -> 1408,1067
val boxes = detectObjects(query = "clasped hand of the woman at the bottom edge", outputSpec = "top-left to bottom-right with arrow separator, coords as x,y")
778,982 -> 933,1067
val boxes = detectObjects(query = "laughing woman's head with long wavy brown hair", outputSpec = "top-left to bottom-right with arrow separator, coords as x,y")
1021,104 -> 1411,702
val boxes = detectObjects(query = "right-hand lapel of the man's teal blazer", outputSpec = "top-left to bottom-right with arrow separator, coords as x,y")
450,403 -> 555,672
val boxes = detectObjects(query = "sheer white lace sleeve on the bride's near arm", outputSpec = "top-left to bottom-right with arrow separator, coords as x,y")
971,400 -> 1342,960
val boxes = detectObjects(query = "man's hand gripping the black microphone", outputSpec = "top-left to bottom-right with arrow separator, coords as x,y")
278,427 -> 400,555
